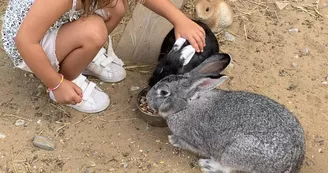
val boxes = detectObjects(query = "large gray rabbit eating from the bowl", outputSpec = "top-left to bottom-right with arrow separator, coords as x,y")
146,54 -> 305,173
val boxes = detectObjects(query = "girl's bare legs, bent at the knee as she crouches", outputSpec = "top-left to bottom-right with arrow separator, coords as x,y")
56,0 -> 126,80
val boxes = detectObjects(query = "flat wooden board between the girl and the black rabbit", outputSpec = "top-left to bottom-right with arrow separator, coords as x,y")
115,0 -> 186,63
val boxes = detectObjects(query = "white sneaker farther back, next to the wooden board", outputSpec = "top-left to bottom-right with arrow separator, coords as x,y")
83,36 -> 126,82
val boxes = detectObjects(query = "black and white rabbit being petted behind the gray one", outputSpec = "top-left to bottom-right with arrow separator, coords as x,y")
148,21 -> 219,87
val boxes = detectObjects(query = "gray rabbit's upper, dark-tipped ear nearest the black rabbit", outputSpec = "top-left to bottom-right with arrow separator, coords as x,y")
188,53 -> 231,77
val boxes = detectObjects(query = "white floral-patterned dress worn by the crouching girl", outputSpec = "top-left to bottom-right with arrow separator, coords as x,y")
2,0 -> 82,66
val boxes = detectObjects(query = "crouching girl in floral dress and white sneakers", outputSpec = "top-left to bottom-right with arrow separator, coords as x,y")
2,0 -> 205,113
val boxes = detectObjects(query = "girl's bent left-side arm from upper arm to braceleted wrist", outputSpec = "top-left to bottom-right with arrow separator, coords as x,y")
15,0 -> 72,88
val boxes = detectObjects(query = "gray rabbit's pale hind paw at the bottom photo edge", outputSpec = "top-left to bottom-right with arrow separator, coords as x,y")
198,159 -> 231,173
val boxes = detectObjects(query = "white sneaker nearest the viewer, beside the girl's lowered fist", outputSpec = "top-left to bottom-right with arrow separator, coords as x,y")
49,75 -> 110,113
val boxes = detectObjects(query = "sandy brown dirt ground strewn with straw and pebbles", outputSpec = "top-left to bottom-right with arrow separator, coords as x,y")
0,0 -> 328,173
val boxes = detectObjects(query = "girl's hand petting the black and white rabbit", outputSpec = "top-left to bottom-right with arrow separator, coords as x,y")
174,18 -> 206,52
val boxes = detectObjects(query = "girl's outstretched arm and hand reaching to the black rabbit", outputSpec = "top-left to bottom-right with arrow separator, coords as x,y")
144,0 -> 205,52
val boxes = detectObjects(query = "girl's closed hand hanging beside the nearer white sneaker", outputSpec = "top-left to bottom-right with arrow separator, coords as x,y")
53,79 -> 82,105
